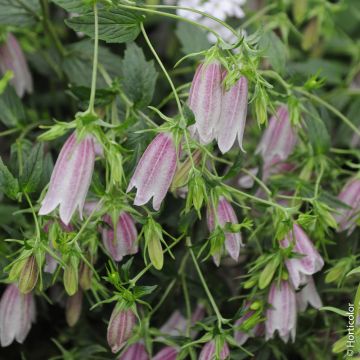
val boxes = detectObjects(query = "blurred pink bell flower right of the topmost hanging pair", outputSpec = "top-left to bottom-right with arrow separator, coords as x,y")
256,106 -> 297,176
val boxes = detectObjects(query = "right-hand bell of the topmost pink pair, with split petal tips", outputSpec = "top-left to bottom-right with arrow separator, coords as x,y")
216,76 -> 248,154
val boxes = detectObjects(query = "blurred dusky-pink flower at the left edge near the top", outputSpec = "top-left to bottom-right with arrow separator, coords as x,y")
0,34 -> 33,97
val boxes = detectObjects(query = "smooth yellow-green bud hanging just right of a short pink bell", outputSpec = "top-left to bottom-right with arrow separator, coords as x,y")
144,218 -> 164,270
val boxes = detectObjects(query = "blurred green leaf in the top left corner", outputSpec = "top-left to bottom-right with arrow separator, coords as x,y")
0,0 -> 40,27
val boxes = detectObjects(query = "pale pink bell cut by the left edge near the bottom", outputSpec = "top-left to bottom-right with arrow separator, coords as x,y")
0,284 -> 36,347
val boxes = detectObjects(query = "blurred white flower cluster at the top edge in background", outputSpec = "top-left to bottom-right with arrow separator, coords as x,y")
165,0 -> 246,43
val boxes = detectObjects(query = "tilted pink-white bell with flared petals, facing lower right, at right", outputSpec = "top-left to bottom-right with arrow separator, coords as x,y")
280,224 -> 324,289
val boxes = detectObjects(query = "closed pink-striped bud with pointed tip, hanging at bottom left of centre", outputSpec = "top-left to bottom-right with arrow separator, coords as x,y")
107,305 -> 136,353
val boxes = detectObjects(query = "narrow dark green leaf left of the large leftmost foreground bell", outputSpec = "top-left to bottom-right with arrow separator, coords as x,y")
20,143 -> 44,194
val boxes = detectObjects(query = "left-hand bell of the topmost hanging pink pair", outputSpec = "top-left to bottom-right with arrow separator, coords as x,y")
188,62 -> 222,144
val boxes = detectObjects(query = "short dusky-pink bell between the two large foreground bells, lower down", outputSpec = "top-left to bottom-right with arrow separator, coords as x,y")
101,212 -> 139,261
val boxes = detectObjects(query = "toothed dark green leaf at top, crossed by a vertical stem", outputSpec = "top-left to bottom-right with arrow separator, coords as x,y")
65,9 -> 143,43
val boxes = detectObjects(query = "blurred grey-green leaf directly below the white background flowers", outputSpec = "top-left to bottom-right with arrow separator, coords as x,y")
176,22 -> 210,54
